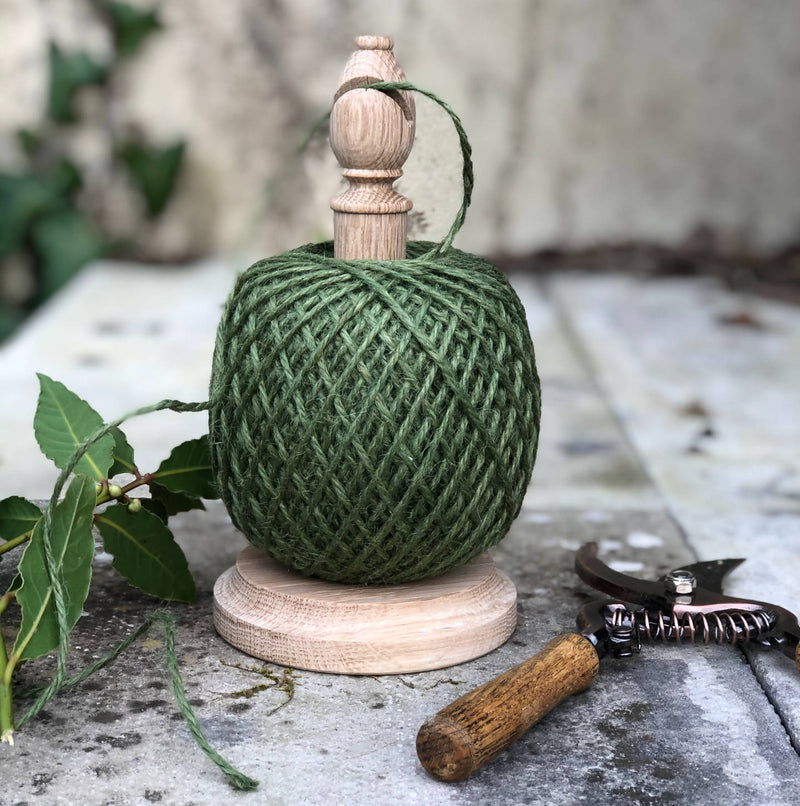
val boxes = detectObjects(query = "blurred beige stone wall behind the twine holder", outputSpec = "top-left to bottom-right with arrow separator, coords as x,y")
0,0 -> 800,260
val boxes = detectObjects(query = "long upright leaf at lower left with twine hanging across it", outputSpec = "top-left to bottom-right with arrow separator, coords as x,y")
13,476 -> 97,660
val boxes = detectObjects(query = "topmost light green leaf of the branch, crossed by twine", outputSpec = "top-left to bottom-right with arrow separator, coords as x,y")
33,373 -> 114,481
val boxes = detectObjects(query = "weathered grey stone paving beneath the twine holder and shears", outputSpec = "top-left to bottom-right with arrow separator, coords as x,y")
0,264 -> 800,806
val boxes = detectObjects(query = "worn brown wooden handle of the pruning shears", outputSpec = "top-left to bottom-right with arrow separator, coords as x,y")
417,633 -> 600,781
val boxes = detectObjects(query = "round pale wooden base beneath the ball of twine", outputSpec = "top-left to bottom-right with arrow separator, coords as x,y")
214,546 -> 517,674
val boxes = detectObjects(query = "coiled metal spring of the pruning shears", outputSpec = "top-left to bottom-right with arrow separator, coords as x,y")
609,607 -> 774,651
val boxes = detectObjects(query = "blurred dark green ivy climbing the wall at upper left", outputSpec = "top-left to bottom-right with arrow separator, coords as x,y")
0,0 -> 186,341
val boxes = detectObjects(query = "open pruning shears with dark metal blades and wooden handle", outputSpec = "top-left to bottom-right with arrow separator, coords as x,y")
417,543 -> 800,781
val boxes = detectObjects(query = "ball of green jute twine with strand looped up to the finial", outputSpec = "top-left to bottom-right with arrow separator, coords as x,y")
209,82 -> 540,583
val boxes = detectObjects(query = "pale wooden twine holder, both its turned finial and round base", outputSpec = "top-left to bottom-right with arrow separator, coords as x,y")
214,36 -> 517,674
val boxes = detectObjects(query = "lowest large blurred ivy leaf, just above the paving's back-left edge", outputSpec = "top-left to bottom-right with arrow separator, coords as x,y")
31,209 -> 105,299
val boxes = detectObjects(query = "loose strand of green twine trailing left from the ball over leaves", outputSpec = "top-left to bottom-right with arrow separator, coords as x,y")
16,400 -> 258,790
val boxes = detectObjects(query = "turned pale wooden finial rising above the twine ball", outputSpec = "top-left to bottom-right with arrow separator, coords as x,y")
331,36 -> 416,260
